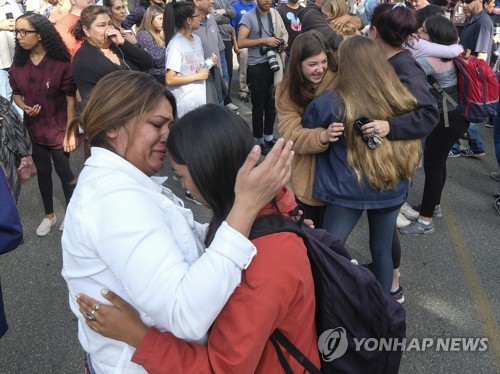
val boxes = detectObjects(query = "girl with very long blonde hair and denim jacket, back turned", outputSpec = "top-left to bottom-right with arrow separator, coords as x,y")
302,36 -> 420,293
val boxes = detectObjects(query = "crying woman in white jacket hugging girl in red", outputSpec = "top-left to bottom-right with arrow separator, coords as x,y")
62,71 -> 293,373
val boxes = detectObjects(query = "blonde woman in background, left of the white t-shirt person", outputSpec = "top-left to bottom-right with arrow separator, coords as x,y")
137,5 -> 166,85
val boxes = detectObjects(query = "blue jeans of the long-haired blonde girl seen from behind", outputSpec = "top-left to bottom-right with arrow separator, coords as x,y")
323,204 -> 399,293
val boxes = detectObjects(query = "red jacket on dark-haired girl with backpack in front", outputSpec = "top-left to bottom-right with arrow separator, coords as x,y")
132,189 -> 320,374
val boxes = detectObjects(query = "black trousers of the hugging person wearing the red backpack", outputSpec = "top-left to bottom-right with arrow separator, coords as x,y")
420,110 -> 472,217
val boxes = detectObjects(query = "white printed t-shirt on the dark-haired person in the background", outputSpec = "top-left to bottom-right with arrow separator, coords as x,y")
166,33 -> 207,118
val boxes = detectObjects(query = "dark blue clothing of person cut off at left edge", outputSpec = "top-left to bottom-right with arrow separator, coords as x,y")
0,168 -> 23,338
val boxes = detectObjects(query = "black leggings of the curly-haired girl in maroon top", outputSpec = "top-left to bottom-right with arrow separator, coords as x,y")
32,143 -> 76,214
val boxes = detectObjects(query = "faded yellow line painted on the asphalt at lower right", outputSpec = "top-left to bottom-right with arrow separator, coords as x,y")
441,196 -> 500,372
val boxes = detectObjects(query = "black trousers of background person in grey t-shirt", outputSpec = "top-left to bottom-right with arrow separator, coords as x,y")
248,61 -> 276,139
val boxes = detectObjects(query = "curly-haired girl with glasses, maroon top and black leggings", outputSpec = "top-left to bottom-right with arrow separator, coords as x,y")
9,13 -> 76,236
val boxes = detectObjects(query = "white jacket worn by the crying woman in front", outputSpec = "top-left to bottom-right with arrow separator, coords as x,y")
62,148 -> 256,373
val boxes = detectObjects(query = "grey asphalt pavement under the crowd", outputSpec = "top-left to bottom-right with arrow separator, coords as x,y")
0,74 -> 500,374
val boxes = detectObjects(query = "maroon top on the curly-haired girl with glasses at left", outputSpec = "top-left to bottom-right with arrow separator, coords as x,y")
9,56 -> 76,149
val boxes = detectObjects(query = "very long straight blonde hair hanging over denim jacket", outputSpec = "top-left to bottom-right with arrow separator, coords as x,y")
334,36 -> 421,190
